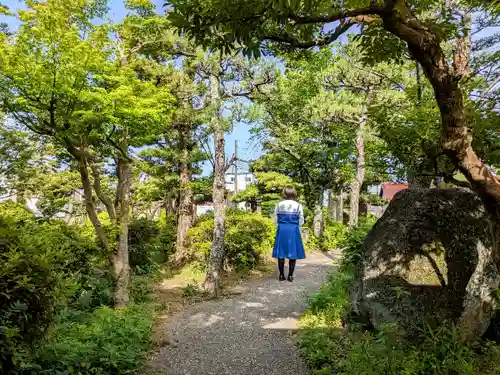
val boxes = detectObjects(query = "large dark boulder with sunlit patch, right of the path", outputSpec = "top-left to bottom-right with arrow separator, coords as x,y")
350,189 -> 499,340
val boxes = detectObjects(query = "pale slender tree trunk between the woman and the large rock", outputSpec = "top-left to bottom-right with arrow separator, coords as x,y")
349,92 -> 371,228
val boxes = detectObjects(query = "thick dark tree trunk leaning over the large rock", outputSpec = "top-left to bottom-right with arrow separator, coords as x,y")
382,0 -> 500,204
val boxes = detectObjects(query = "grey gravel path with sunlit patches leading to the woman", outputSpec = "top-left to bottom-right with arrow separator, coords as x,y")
146,253 -> 333,375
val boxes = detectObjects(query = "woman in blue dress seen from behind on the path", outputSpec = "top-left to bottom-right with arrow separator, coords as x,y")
273,186 -> 306,282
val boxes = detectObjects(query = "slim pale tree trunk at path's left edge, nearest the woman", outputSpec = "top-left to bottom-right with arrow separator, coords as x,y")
204,75 -> 226,297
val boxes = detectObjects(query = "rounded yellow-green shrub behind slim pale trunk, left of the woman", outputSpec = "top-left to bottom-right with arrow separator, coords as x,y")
188,210 -> 275,270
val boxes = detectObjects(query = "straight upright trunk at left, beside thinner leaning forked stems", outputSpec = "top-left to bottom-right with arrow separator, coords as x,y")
113,158 -> 131,307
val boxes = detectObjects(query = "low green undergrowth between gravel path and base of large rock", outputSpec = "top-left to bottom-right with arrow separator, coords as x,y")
299,216 -> 500,375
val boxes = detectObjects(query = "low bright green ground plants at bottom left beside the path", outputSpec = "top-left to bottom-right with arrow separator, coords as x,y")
32,305 -> 154,375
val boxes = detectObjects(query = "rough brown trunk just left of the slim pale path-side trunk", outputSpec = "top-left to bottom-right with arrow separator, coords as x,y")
174,137 -> 193,267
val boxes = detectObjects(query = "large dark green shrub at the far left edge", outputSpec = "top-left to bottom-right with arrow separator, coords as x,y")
0,203 -> 97,373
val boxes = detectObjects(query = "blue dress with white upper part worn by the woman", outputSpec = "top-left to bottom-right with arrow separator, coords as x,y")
273,204 -> 306,259
